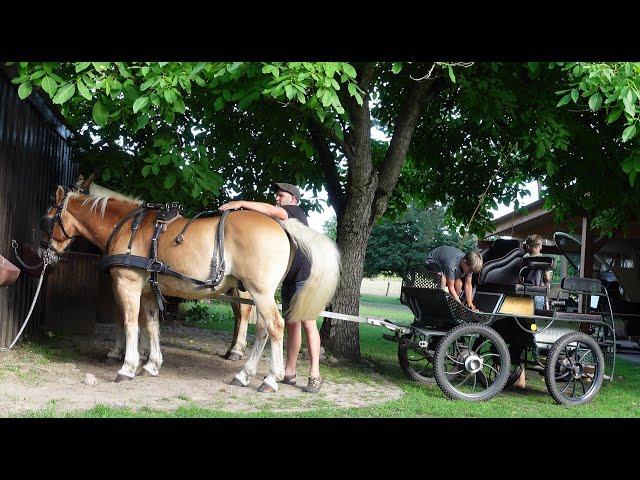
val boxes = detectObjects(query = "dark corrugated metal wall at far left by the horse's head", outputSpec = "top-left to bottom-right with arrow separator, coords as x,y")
0,70 -> 82,346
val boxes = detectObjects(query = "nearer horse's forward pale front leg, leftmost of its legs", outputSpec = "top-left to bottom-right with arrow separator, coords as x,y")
112,268 -> 143,382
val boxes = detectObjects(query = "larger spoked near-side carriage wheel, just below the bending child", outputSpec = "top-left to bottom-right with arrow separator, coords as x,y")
434,324 -> 510,401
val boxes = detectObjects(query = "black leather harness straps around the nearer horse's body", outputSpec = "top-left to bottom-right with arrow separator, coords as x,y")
99,203 -> 231,314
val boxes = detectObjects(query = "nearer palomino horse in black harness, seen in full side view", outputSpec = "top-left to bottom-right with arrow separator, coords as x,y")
41,182 -> 340,391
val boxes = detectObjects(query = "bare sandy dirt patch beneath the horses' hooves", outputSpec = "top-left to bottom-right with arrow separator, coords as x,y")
0,325 -> 402,417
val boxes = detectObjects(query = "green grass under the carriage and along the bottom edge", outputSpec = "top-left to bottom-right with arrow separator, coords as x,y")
13,297 -> 640,418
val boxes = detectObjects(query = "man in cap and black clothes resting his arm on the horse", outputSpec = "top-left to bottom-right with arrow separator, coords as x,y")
219,183 -> 323,393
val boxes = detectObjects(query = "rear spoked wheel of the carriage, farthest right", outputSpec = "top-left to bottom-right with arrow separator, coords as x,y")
544,332 -> 604,406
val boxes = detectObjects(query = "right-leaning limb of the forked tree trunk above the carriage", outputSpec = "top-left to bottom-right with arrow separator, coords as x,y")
370,80 -> 438,225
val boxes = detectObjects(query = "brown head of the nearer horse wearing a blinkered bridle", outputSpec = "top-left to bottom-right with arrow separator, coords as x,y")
38,186 -> 78,263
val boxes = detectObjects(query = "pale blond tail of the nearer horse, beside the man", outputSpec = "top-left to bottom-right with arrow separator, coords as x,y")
282,218 -> 340,322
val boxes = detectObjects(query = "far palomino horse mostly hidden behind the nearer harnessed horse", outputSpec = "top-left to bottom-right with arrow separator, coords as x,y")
75,178 -> 257,361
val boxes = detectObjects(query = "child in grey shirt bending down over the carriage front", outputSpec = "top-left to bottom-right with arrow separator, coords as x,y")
426,245 -> 482,311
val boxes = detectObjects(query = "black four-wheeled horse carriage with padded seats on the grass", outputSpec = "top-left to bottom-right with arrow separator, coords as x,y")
385,240 -> 615,406
